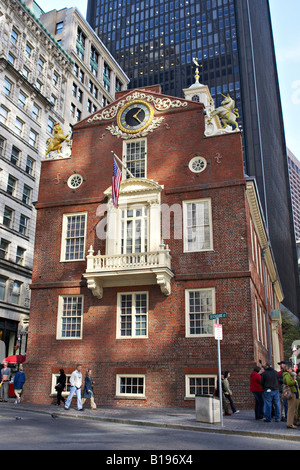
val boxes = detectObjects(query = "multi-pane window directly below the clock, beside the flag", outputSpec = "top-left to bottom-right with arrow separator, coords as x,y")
124,139 -> 146,178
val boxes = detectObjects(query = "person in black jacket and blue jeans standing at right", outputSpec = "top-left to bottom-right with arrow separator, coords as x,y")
260,362 -> 280,423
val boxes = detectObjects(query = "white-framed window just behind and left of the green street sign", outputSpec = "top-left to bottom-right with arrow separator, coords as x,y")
185,288 -> 215,337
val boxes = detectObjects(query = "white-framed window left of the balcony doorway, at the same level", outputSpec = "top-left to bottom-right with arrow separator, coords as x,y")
61,213 -> 86,261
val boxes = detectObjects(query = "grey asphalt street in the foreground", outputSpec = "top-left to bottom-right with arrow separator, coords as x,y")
0,406 -> 299,452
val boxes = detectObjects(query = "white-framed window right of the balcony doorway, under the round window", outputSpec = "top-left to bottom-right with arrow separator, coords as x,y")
183,199 -> 213,252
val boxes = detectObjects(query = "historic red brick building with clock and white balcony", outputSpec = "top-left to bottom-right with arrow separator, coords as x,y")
24,87 -> 282,407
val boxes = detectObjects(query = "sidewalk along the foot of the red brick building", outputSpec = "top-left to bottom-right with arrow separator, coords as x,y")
0,399 -> 300,442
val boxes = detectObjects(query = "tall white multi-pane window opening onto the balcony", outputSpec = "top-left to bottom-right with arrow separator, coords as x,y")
121,206 -> 148,254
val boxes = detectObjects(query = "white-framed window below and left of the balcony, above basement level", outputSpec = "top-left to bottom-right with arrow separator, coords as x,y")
57,295 -> 83,339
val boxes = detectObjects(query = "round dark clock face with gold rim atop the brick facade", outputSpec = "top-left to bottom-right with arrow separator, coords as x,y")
117,100 -> 153,134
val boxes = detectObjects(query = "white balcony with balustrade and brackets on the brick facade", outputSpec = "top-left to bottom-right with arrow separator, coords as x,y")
83,244 -> 174,299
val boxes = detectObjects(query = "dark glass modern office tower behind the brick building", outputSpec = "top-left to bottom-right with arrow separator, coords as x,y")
87,0 -> 300,320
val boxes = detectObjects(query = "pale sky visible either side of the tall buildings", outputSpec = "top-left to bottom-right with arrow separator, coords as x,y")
36,0 -> 300,160
